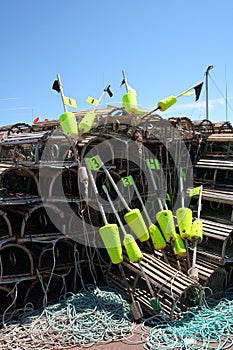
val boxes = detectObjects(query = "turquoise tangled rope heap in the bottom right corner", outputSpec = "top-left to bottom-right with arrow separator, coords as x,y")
144,290 -> 233,350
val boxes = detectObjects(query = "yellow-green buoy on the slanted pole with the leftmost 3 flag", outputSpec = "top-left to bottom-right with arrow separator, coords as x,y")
124,208 -> 150,242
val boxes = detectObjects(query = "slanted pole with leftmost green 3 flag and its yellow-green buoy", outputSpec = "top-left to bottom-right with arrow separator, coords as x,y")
87,155 -> 150,242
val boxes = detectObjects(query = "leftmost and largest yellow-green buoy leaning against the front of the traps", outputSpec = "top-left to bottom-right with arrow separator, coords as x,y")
99,224 -> 123,264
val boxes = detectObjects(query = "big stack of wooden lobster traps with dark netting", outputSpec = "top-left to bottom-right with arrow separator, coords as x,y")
0,112 -> 233,317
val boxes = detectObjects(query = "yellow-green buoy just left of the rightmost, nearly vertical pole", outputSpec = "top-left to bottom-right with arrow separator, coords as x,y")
176,208 -> 193,239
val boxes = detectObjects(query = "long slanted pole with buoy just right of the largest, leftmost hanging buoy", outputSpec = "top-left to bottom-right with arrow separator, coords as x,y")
102,185 -> 161,312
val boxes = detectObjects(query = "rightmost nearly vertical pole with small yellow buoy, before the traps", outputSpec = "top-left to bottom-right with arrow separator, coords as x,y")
188,185 -> 203,281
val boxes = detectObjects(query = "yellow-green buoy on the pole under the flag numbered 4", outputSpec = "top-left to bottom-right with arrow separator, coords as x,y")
156,210 -> 176,242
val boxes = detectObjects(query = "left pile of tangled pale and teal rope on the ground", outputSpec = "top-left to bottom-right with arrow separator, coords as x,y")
0,285 -> 133,350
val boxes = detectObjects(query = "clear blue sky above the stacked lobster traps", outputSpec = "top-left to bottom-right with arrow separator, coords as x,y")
0,0 -> 233,125
